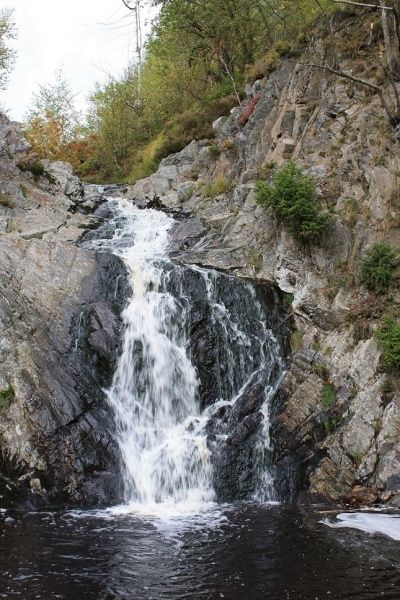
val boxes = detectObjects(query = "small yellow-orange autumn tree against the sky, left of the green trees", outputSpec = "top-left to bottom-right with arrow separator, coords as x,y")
25,71 -> 78,159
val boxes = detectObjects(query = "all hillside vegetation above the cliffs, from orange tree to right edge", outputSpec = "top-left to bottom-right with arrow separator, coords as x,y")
19,0 -> 400,182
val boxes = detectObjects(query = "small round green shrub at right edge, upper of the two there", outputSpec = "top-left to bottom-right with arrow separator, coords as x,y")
360,242 -> 398,294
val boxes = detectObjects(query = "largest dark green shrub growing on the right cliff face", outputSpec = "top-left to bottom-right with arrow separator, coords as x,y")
256,161 -> 331,242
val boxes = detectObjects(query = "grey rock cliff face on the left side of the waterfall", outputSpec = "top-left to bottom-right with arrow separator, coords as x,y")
0,116 -> 123,504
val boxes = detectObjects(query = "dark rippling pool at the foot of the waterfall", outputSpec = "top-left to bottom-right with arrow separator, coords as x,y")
0,505 -> 400,600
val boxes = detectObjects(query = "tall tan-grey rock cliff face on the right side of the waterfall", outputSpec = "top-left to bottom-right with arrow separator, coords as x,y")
130,15 -> 400,505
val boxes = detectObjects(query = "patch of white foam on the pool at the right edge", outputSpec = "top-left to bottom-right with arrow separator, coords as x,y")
322,512 -> 400,541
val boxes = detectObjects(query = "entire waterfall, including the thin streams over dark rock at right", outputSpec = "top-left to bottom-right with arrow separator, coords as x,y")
86,199 -> 282,508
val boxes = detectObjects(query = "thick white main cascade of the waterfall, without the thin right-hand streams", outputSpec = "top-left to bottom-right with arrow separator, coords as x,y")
96,200 -> 213,510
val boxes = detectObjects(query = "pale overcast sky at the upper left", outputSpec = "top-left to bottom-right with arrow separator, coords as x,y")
0,0 -> 154,120
